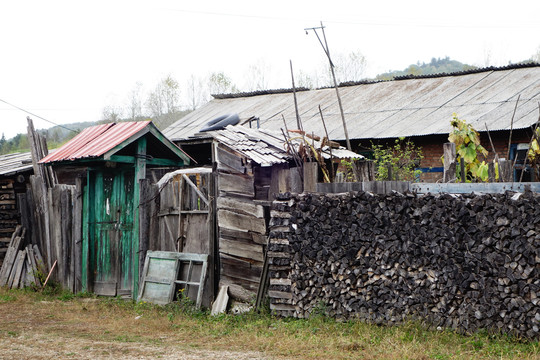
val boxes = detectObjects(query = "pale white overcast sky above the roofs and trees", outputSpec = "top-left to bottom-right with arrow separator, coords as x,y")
0,0 -> 540,138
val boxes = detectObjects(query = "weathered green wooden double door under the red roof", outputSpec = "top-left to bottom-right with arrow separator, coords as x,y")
88,168 -> 135,296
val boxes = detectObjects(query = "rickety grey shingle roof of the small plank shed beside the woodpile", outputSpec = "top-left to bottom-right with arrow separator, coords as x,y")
196,125 -> 363,166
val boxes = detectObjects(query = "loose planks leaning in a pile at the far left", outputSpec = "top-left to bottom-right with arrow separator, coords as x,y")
0,225 -> 45,289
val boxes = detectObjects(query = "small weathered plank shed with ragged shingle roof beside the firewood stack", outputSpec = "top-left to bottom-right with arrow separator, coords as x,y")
171,126 -> 362,301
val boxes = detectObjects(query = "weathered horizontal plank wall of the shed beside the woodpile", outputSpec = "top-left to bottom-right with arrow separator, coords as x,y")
215,144 -> 266,300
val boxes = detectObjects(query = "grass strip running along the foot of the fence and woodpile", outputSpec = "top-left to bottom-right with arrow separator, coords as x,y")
0,289 -> 540,360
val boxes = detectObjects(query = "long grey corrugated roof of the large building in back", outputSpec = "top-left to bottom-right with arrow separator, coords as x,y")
164,64 -> 540,140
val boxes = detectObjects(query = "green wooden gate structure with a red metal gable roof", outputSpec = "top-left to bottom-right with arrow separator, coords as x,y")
40,121 -> 189,298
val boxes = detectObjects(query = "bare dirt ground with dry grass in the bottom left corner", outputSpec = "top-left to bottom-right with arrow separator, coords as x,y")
0,301 -> 272,360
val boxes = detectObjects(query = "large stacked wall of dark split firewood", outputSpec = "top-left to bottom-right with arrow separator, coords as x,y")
270,192 -> 540,338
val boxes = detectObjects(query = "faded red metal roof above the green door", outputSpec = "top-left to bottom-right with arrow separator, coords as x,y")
39,121 -> 150,164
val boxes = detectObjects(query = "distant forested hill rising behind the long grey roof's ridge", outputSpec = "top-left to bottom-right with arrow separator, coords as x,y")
376,56 -> 476,80
